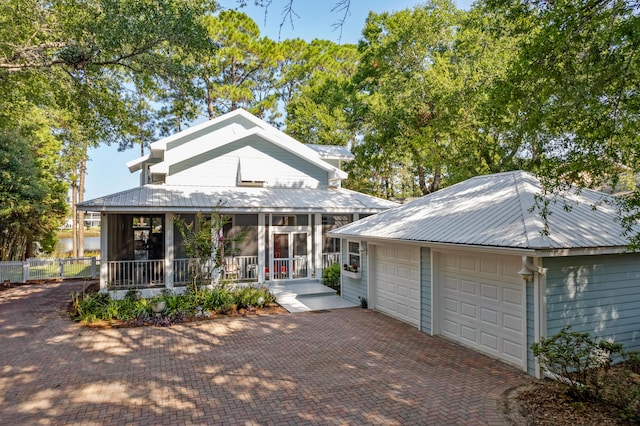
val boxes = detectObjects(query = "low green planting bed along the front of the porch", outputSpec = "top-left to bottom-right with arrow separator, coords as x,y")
69,286 -> 284,326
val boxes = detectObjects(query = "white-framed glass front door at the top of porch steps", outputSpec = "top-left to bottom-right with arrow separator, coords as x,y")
270,232 -> 309,280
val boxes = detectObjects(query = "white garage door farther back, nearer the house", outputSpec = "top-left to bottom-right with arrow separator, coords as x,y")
373,245 -> 420,326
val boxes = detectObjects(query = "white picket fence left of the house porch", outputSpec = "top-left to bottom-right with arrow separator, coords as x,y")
0,257 -> 99,283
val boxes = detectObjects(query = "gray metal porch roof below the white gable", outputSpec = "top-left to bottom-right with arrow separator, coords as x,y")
78,185 -> 398,213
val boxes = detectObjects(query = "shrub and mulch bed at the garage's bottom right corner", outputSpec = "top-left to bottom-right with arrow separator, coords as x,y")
505,327 -> 640,425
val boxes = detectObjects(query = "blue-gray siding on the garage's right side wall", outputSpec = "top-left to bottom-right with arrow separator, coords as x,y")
544,254 -> 640,350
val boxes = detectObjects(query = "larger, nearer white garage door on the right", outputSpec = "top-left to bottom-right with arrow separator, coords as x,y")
438,253 -> 526,367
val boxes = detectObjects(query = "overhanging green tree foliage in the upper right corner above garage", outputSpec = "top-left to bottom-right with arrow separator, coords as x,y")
478,0 -> 640,240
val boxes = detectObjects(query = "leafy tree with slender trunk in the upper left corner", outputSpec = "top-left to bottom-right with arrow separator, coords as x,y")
0,0 -> 214,256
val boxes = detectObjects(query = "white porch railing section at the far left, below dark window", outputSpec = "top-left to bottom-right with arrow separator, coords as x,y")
107,259 -> 164,288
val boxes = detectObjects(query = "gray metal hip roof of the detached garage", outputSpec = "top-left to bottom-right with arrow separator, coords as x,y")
331,171 -> 628,249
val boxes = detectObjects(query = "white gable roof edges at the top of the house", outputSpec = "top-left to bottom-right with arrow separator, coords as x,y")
127,108 -> 348,180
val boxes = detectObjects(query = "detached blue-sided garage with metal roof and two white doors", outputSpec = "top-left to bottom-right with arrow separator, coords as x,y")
329,171 -> 640,376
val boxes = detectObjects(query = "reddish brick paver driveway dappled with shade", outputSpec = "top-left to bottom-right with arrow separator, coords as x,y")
0,283 -> 528,425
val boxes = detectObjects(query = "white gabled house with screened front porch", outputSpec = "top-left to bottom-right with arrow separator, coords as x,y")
78,109 -> 396,297
